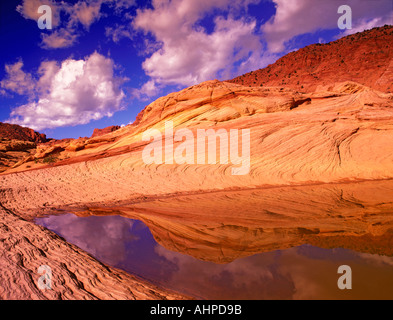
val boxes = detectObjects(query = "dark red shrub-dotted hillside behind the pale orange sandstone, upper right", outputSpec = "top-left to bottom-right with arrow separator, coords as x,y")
230,26 -> 393,92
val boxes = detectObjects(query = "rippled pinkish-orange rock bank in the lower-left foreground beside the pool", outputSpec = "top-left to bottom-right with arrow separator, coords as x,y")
0,204 -> 191,300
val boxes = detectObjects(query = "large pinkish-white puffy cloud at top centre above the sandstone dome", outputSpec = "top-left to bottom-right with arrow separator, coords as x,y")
134,0 -> 262,92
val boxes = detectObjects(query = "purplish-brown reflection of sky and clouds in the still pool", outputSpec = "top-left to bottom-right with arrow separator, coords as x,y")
36,214 -> 393,299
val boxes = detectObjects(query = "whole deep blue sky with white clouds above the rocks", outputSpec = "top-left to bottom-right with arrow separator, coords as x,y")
0,0 -> 393,139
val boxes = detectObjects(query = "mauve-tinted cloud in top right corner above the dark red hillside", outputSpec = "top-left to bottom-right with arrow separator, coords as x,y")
261,0 -> 392,52
